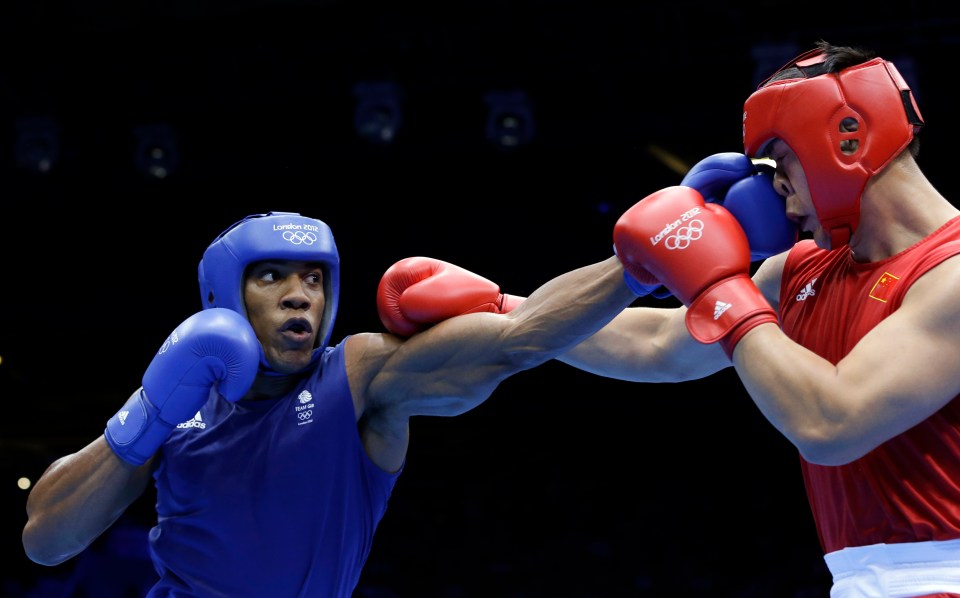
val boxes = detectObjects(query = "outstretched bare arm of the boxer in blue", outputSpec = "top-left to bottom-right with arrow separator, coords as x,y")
367,257 -> 636,418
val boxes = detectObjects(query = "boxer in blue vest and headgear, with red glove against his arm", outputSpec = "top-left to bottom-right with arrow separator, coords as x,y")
23,212 -> 635,598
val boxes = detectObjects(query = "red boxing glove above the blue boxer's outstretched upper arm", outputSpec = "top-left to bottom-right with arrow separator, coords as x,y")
377,257 -> 523,336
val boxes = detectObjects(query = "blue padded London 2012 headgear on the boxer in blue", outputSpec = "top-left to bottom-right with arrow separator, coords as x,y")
198,212 -> 340,367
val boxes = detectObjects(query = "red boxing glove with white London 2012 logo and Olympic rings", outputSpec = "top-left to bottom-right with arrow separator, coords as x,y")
613,186 -> 777,356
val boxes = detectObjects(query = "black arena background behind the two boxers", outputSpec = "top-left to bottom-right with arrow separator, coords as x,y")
0,0 -> 960,598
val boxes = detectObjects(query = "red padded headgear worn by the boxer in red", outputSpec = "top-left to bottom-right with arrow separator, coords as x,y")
743,50 -> 923,248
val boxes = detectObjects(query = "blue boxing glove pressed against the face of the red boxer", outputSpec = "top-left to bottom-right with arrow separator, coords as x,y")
680,152 -> 799,262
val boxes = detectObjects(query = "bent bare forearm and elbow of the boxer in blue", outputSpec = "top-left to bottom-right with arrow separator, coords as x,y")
23,436 -> 150,565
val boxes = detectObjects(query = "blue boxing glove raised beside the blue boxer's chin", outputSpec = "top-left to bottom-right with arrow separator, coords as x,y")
103,307 -> 260,465
